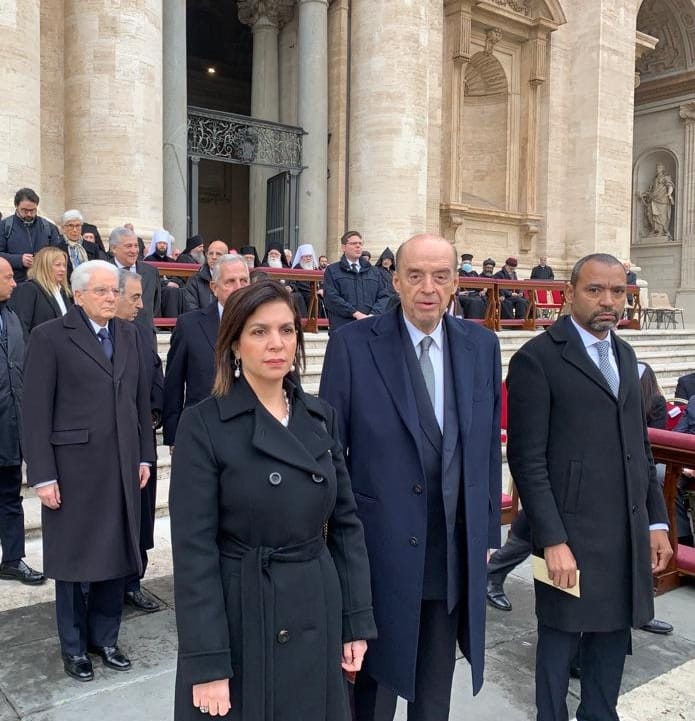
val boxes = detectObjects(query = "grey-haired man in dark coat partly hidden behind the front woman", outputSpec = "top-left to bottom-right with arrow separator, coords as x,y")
162,254 -> 249,448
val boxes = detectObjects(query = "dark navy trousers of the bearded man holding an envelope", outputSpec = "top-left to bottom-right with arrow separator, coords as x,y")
536,623 -> 630,721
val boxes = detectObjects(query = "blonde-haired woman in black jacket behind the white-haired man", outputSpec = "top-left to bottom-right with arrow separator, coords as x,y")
12,246 -> 72,333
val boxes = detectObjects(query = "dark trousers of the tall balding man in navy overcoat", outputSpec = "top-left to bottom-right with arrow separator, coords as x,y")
355,601 -> 458,721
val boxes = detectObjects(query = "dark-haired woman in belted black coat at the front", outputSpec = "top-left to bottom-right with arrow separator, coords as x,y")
170,280 -> 376,721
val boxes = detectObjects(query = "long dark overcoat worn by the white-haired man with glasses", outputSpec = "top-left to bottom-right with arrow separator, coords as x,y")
23,306 -> 155,581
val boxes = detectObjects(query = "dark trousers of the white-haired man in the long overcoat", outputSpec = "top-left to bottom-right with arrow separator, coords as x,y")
56,578 -> 125,656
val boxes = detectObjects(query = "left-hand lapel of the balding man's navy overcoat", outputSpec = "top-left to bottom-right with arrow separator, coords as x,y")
368,310 -> 420,448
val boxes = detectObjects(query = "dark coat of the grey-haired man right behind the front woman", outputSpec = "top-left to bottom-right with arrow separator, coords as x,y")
162,303 -> 220,446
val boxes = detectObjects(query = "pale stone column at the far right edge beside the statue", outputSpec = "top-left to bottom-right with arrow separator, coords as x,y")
676,102 -> 695,322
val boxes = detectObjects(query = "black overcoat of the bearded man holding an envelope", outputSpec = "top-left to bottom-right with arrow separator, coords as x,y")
507,316 -> 668,632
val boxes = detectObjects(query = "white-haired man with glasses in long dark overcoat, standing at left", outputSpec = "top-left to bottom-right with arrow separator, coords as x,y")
24,260 -> 154,681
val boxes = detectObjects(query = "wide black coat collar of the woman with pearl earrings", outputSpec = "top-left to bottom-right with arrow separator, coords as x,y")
217,376 -> 334,475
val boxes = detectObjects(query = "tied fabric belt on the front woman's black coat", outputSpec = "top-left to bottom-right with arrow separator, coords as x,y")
217,536 -> 326,721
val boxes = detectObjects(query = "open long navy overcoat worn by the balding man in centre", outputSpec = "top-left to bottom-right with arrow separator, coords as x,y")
320,309 -> 501,698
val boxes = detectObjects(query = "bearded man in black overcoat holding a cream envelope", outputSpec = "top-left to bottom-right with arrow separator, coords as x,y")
507,254 -> 672,721
